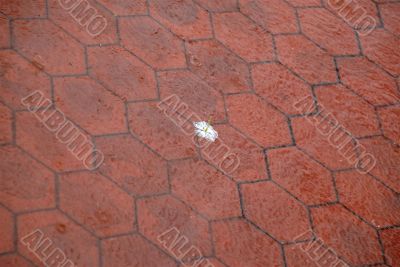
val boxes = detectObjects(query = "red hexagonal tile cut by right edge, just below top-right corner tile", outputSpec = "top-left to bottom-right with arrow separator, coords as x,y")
360,29 -> 400,75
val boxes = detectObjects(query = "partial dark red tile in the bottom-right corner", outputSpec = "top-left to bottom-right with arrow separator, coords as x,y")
381,228 -> 400,267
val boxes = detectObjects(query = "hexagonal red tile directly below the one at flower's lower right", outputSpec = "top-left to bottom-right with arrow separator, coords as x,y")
241,182 -> 311,242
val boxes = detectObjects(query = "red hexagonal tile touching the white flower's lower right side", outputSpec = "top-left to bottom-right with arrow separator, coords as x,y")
199,125 -> 267,182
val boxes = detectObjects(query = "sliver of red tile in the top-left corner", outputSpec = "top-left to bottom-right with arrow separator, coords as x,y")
0,0 -> 46,18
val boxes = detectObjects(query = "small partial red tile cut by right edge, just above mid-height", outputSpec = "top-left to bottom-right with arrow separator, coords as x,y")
378,106 -> 400,145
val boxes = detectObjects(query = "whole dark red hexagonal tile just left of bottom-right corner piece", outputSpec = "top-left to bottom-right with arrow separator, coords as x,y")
311,205 -> 382,265
